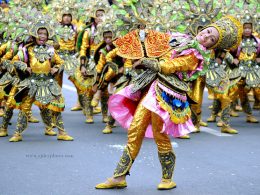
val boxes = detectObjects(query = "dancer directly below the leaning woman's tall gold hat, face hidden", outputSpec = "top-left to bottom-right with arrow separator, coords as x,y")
206,48 -> 241,134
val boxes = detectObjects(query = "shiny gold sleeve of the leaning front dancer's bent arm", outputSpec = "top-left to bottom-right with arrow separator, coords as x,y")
159,53 -> 199,74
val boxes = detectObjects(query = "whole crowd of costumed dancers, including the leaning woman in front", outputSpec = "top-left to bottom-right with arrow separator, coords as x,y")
0,0 -> 260,189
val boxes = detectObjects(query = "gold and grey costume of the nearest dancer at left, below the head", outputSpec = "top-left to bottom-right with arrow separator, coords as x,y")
10,44 -> 73,142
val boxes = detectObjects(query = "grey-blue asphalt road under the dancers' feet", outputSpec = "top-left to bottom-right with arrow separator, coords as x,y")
0,79 -> 260,195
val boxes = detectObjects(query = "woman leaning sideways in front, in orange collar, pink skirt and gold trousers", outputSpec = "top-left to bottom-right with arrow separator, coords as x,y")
96,2 -> 242,190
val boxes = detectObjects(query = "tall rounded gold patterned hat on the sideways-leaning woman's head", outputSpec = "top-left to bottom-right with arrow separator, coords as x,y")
207,16 -> 243,49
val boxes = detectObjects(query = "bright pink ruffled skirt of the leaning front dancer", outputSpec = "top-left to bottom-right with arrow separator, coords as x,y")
108,81 -> 195,138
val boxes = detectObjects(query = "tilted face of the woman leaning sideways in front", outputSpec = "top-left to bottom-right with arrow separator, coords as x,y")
196,27 -> 219,48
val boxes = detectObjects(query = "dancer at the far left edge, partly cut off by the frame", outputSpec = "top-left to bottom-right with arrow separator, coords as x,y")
0,7 -> 39,137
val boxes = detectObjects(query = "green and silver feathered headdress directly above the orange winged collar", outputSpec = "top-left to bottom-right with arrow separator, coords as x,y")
112,0 -> 181,32
